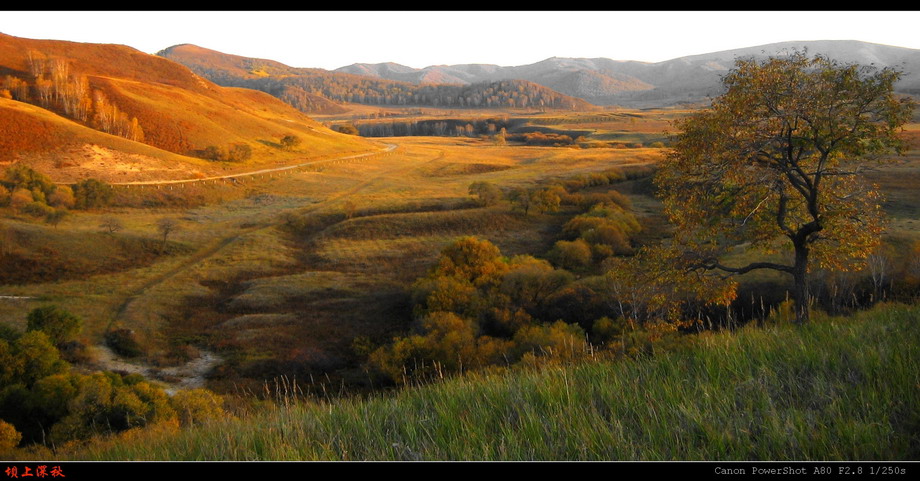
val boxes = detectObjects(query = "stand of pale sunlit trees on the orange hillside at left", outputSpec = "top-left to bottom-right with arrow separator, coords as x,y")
0,51 -> 144,142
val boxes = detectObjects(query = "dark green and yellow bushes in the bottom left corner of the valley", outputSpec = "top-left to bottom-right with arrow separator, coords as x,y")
0,306 -> 224,450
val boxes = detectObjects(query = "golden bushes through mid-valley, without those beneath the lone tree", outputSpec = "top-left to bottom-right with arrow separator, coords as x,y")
369,168 -> 676,382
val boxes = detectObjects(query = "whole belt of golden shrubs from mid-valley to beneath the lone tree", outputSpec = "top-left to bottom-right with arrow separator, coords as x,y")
368,169 -> 752,383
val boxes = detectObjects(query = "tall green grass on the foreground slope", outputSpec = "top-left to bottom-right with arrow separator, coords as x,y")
66,305 -> 920,460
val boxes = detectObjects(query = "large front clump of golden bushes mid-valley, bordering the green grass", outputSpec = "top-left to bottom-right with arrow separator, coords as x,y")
369,237 -> 588,383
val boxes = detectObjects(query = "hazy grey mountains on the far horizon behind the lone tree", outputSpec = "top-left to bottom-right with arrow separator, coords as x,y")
335,40 -> 920,106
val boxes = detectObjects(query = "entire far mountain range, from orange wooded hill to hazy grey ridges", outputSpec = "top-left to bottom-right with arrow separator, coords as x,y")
158,40 -> 920,113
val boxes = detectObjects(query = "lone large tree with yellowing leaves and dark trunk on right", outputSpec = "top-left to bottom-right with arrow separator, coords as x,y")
655,51 -> 913,323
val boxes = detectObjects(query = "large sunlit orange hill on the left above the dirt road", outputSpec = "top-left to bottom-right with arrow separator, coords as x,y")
0,34 -> 378,181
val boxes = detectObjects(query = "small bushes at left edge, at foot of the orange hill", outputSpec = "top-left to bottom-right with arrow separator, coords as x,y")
0,164 -> 114,224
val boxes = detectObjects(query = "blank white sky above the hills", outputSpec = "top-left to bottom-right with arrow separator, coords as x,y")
0,10 -> 920,70
